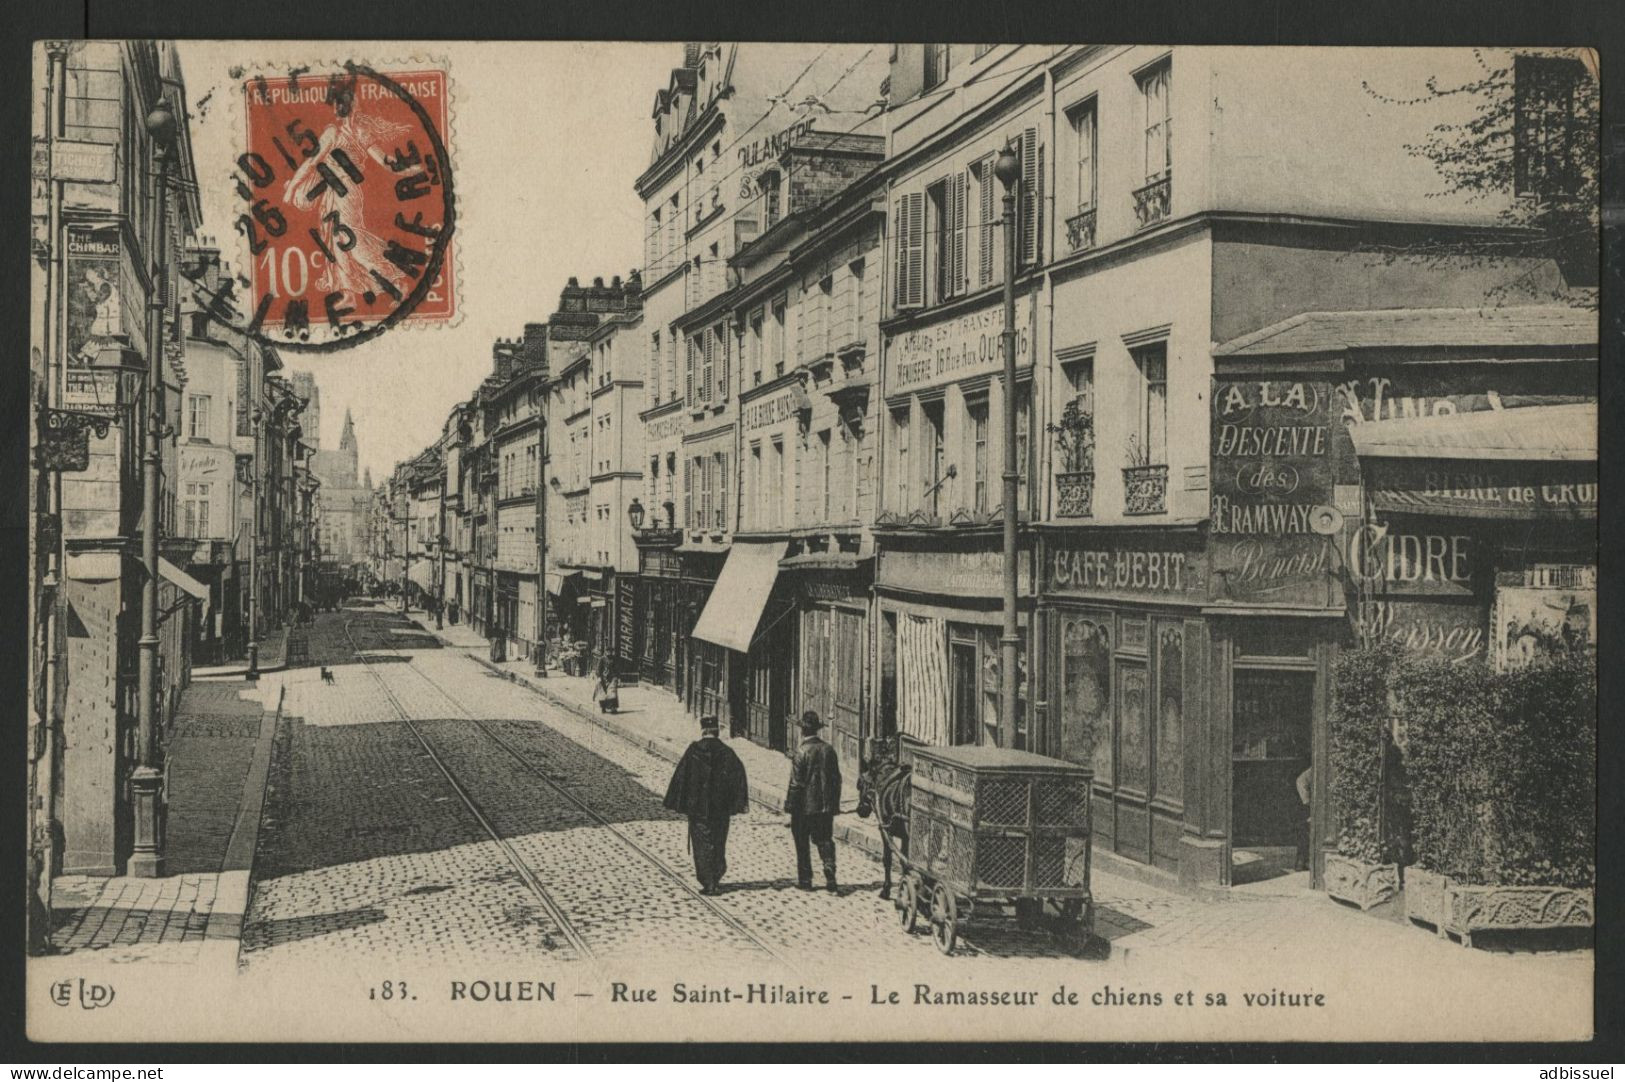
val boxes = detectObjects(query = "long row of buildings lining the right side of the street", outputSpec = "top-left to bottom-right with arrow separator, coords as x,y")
372,42 -> 1597,887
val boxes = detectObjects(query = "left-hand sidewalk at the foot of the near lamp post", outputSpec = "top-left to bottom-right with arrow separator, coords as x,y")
41,682 -> 281,967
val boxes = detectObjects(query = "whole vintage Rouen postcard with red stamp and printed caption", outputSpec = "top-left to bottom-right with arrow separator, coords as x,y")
26,41 -> 1599,1041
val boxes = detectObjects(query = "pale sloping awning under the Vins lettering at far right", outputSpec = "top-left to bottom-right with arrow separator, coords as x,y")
1349,403 -> 1597,461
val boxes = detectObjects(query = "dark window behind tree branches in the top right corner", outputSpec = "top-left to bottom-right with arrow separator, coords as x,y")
1513,57 -> 1586,197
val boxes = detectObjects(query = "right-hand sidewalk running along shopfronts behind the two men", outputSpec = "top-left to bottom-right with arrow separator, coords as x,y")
413,617 -> 881,858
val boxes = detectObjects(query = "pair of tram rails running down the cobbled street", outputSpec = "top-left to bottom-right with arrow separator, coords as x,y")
345,621 -> 796,970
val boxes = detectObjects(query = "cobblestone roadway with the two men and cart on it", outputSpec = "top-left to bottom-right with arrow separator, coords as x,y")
242,609 -> 1589,1000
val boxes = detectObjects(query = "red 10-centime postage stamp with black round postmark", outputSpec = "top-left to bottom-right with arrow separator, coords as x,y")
234,63 -> 457,349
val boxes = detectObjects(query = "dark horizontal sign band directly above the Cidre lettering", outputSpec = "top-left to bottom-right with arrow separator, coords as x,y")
1365,458 -> 1597,518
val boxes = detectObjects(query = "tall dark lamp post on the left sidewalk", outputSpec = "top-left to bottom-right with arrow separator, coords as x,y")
128,97 -> 176,877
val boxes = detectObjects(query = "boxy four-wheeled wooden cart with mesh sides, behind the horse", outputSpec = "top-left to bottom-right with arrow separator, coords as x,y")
881,746 -> 1094,954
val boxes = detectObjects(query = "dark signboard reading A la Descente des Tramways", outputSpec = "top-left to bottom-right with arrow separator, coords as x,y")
1211,380 -> 1339,606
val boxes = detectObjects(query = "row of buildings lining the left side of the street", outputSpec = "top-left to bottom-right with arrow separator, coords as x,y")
29,41 -> 319,905
